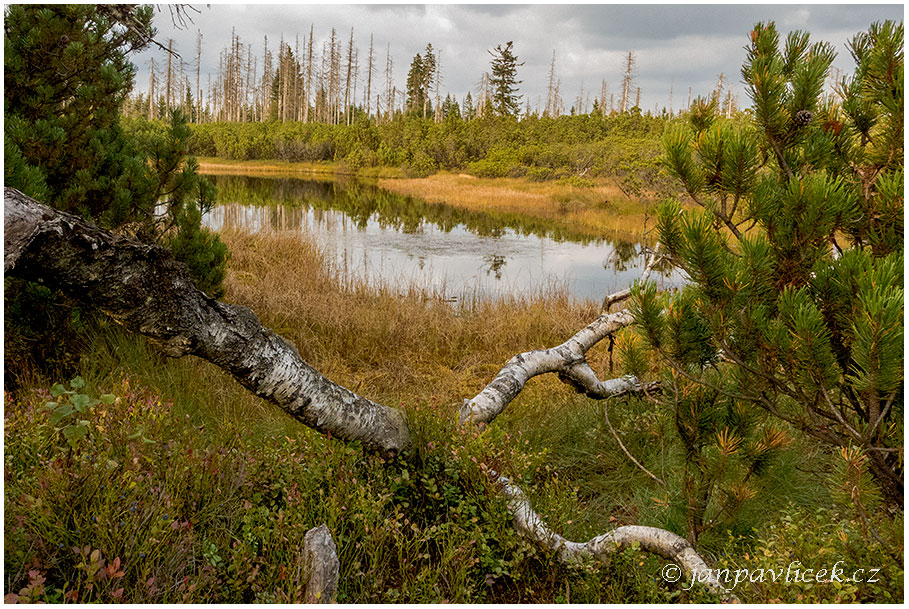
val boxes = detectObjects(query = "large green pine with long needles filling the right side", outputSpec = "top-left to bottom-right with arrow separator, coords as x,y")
632,22 -> 903,506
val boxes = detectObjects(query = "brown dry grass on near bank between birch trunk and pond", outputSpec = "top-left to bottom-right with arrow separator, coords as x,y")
215,232 -> 608,414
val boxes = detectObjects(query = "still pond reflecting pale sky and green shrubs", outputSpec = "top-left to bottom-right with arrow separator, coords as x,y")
203,175 -> 680,302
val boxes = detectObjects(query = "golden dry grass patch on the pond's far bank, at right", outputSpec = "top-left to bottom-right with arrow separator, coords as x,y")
379,173 -> 653,239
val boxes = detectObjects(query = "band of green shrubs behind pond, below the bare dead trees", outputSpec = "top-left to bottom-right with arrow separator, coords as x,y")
187,113 -> 669,186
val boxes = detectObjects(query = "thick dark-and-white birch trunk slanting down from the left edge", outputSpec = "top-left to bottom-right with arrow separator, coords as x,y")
3,188 -> 410,454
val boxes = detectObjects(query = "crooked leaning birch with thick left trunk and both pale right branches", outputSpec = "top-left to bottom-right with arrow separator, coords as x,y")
4,188 -> 731,598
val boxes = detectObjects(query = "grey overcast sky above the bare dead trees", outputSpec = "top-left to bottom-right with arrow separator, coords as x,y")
133,2 -> 904,111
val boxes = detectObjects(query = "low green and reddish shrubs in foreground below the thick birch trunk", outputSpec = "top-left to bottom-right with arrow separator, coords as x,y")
5,378 -> 668,603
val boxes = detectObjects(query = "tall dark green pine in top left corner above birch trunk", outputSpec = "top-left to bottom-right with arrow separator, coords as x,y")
4,5 -> 154,220
